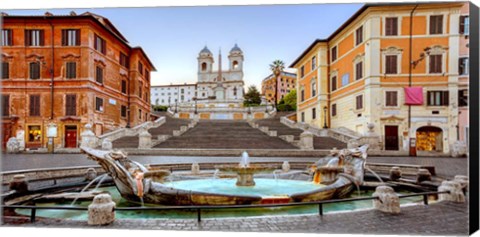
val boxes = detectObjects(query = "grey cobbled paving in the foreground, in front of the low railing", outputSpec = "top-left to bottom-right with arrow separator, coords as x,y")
4,202 -> 469,235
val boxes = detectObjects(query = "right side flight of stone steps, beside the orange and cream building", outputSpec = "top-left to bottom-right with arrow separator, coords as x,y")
255,112 -> 347,150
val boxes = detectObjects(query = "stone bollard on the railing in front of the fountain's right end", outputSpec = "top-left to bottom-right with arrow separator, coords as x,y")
372,186 -> 400,213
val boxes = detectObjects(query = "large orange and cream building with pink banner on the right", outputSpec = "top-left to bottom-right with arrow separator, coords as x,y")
290,2 -> 469,154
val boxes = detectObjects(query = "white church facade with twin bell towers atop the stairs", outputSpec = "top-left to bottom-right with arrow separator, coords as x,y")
197,44 -> 244,102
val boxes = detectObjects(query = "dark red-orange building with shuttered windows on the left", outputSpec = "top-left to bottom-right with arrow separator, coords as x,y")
0,12 -> 155,149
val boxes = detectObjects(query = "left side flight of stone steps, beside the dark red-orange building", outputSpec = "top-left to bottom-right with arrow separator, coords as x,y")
112,112 -> 191,148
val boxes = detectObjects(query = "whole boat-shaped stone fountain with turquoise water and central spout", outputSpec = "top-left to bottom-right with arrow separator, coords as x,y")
81,146 -> 368,205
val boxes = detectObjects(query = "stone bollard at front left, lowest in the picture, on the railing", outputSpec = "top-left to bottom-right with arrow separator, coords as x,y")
88,194 -> 115,225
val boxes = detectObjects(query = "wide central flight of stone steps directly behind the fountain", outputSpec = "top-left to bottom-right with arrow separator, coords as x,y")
155,120 -> 298,149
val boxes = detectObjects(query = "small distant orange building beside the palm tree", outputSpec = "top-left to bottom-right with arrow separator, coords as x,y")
262,72 -> 297,103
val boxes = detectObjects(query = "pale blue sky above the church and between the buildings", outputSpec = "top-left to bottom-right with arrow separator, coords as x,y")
5,3 -> 363,89
